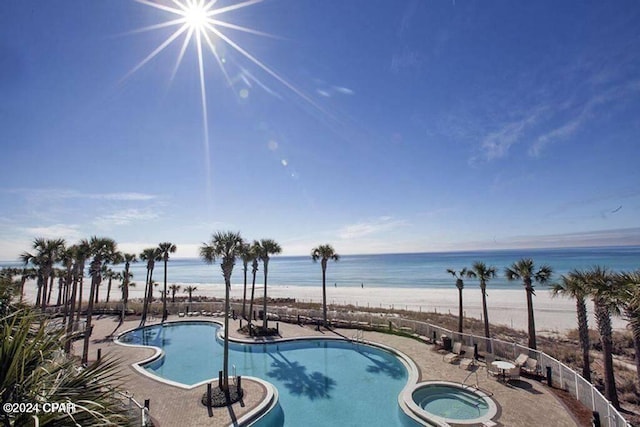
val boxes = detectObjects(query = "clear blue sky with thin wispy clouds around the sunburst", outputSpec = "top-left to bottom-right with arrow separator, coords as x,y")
0,0 -> 640,260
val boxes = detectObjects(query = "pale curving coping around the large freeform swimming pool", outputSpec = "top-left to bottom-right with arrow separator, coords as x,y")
113,319 -> 428,425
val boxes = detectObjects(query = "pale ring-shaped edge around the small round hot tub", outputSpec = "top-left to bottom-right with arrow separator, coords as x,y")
400,380 -> 498,427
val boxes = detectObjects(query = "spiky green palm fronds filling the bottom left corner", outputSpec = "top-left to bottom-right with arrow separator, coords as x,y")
0,310 -> 134,426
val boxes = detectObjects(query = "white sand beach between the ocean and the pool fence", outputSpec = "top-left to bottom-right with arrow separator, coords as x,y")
20,281 -> 626,333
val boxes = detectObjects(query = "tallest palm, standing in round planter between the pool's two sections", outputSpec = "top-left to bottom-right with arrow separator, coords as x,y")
200,231 -> 244,392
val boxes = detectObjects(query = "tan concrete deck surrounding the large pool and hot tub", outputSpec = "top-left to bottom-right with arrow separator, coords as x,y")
74,316 -> 578,427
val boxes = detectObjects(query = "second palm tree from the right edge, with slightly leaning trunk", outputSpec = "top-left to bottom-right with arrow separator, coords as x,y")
586,266 -> 621,409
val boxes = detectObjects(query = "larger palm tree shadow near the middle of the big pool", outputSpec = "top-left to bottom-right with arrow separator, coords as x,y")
267,353 -> 336,400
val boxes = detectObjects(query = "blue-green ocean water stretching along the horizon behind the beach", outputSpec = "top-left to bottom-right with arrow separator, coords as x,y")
0,246 -> 640,289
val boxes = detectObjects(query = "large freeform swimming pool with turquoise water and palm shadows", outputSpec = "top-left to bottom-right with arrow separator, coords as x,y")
119,322 -> 417,426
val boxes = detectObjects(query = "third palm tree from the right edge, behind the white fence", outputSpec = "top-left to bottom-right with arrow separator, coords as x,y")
551,270 -> 591,382
